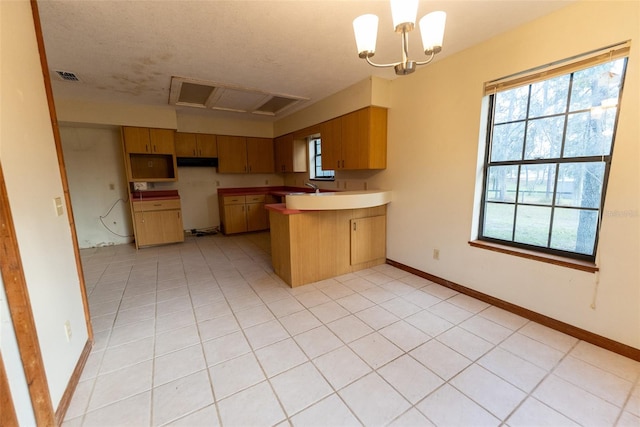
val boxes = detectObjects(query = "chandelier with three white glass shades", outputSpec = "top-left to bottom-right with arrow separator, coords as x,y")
353,0 -> 447,76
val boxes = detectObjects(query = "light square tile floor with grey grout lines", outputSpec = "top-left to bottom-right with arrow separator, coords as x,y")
64,233 -> 640,427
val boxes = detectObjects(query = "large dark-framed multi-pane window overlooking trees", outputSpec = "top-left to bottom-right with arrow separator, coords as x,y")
478,46 -> 627,261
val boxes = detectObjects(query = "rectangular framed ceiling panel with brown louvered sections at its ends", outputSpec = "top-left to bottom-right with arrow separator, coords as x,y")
169,76 -> 308,116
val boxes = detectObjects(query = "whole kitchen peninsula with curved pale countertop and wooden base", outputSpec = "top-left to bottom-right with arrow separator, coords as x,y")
266,191 -> 391,287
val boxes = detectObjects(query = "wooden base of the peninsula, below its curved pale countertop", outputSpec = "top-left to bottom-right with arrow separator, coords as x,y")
269,205 -> 386,287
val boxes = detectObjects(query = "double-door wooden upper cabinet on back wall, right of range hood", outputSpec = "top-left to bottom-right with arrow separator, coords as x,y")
216,135 -> 274,173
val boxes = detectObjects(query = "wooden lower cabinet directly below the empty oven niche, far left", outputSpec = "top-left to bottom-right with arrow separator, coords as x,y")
133,200 -> 184,247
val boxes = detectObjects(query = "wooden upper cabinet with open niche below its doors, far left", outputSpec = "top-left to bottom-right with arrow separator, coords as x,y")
122,127 -> 178,182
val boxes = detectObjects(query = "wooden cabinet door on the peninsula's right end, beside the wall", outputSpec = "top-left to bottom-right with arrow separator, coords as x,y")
350,215 -> 387,265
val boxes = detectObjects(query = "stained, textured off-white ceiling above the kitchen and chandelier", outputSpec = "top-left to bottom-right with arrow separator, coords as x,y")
38,0 -> 570,120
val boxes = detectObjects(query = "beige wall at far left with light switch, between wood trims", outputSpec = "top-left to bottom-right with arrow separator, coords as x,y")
0,0 -> 88,409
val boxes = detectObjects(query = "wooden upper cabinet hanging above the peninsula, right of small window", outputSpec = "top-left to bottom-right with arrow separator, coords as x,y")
320,107 -> 387,170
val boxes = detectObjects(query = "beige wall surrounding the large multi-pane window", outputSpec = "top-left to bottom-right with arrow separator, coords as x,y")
372,1 -> 640,348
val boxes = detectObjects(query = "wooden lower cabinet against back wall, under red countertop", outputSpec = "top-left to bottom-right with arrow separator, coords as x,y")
218,194 -> 269,234
